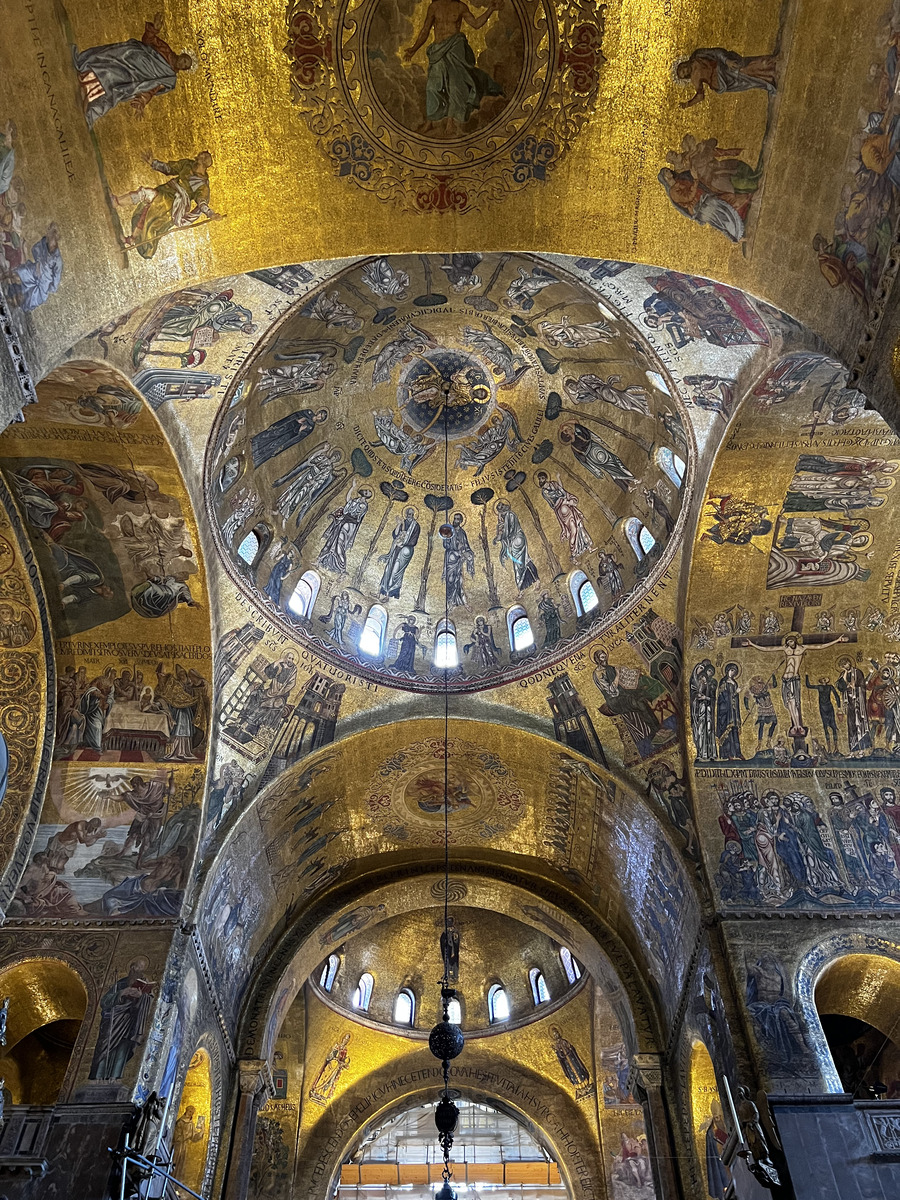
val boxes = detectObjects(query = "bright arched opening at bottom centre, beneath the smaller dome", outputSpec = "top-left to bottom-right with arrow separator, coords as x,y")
336,1097 -> 569,1200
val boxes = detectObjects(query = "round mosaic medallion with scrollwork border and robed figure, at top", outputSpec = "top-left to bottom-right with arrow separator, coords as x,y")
284,0 -> 606,212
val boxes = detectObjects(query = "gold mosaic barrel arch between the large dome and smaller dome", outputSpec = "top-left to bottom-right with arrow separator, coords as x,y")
198,719 -> 700,1052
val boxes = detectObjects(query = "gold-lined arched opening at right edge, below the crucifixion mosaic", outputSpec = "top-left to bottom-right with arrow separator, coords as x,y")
815,954 -> 900,1099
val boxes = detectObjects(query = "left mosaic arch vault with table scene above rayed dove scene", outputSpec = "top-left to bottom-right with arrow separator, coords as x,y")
0,358 -> 214,919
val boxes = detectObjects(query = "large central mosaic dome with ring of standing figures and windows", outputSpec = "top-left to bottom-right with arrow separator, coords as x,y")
206,254 -> 689,690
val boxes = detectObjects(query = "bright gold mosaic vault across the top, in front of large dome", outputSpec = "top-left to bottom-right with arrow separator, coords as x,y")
0,0 -> 898,412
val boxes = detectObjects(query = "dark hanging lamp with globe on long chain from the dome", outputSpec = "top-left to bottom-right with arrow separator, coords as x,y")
428,376 -> 464,1200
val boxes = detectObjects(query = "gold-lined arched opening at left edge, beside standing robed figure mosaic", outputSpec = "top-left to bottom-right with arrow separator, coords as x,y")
0,959 -> 88,1104
